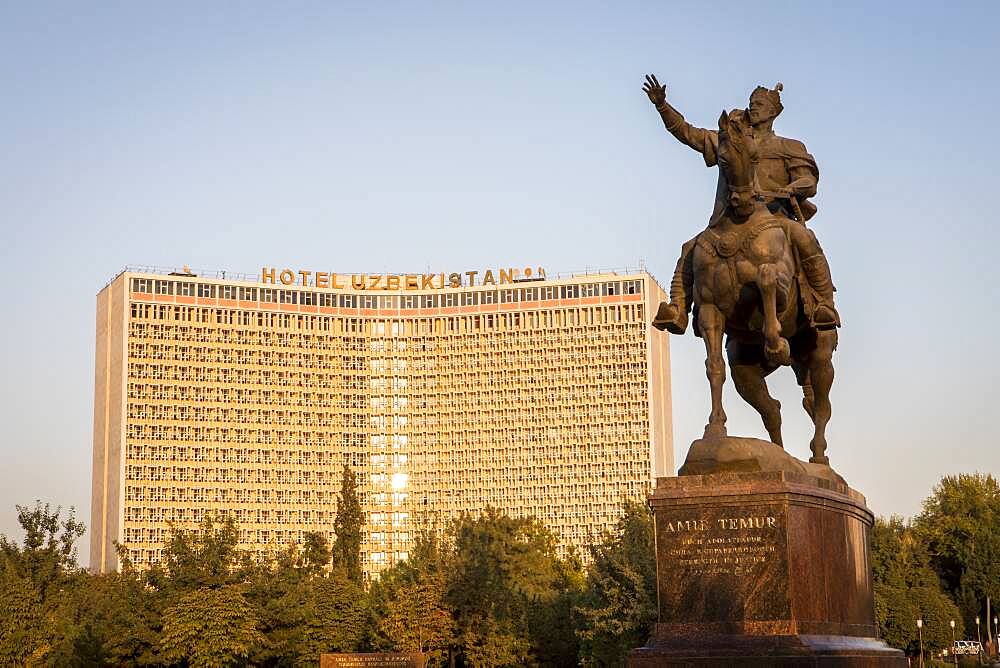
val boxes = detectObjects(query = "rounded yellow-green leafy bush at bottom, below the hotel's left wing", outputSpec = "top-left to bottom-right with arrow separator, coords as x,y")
159,586 -> 264,668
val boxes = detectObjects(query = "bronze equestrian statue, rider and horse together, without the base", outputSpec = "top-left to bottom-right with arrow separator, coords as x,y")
643,75 -> 840,464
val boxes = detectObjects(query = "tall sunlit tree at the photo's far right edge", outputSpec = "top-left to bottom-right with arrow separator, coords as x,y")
913,473 -> 1000,625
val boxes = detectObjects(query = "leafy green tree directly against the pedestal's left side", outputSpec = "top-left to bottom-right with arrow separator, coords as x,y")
577,502 -> 657,666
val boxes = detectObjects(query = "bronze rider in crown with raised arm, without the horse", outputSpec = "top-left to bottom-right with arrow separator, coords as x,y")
643,76 -> 840,334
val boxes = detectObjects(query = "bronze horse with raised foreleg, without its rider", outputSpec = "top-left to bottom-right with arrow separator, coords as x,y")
692,110 -> 837,465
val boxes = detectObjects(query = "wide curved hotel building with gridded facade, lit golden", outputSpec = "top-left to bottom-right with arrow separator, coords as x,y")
90,268 -> 673,576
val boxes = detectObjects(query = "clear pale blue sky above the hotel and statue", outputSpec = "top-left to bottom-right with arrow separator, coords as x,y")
0,2 -> 1000,561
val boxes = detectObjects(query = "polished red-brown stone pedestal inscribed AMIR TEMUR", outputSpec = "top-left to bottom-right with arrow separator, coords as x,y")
629,468 -> 906,668
